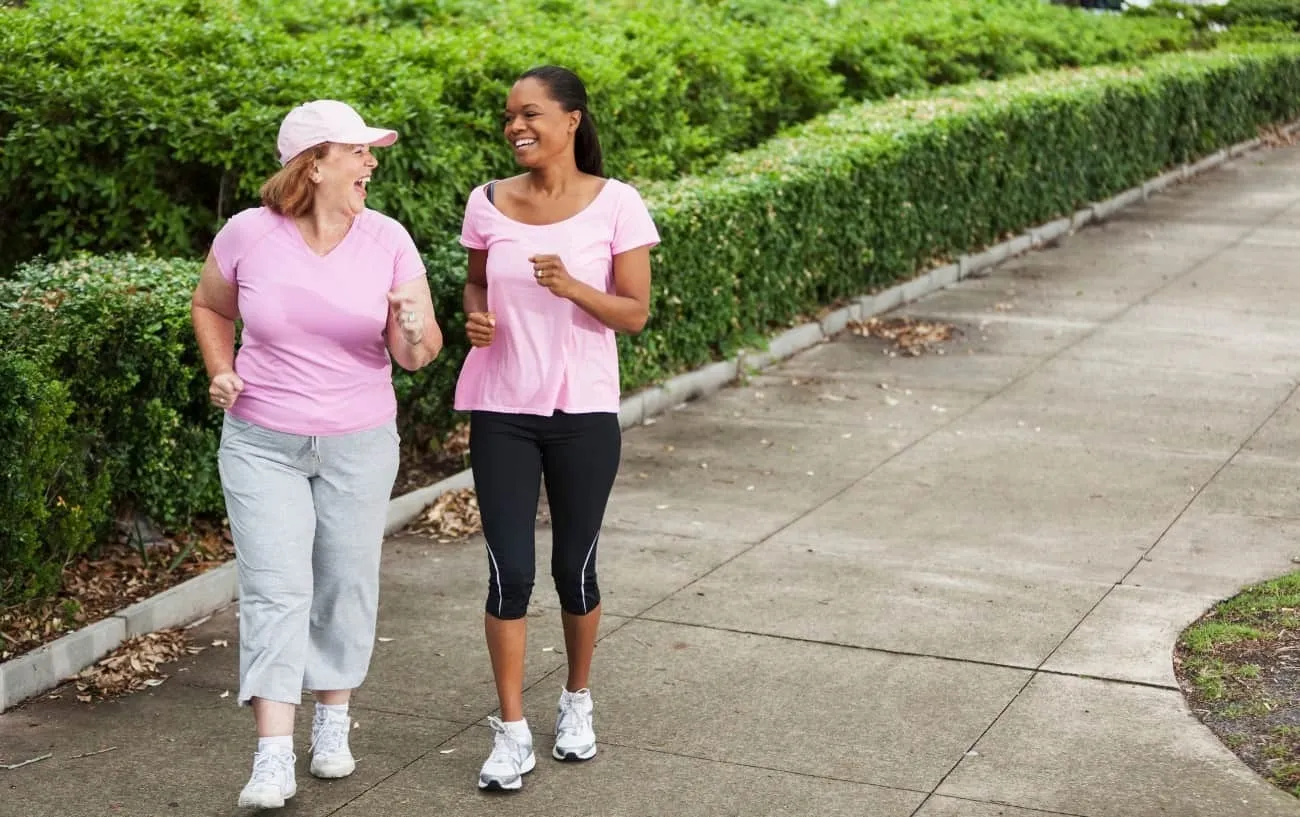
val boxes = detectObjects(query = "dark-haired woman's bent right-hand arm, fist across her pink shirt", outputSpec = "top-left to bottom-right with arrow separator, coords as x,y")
530,246 -> 650,334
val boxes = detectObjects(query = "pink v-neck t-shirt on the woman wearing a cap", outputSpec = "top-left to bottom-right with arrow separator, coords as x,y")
212,207 -> 425,436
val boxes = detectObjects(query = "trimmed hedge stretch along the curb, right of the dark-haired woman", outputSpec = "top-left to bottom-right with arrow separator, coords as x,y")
620,47 -> 1300,384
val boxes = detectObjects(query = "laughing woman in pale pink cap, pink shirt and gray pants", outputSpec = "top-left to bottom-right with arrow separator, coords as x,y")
191,100 -> 442,808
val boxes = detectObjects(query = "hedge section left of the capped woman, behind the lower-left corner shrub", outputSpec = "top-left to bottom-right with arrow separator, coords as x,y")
0,255 -> 221,526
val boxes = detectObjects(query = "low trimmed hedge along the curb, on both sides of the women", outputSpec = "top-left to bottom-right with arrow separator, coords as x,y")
0,47 -> 1300,606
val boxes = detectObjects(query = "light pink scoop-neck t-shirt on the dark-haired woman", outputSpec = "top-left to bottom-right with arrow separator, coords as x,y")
455,178 -> 659,416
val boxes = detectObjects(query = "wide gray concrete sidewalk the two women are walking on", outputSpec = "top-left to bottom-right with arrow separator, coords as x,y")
0,148 -> 1300,817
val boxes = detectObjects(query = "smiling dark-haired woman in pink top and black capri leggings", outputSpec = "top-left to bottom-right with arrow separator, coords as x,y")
455,66 -> 659,790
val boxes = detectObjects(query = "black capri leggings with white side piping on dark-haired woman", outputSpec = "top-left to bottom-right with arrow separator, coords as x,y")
469,411 -> 623,619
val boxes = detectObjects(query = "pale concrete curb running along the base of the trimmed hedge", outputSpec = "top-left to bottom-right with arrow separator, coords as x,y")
0,122 -> 1300,712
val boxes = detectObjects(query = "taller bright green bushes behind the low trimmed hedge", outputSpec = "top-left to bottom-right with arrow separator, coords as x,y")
0,0 -> 1203,275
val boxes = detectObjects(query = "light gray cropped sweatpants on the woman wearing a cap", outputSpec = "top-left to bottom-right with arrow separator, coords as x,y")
217,415 -> 398,704
